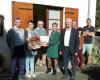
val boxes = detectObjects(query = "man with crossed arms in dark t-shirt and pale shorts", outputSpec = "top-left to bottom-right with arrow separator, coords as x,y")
83,18 -> 95,65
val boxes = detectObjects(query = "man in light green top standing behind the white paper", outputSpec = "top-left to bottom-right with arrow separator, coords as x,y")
34,20 -> 47,66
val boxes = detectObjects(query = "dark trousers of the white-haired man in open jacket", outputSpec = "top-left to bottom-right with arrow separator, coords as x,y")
63,47 -> 76,80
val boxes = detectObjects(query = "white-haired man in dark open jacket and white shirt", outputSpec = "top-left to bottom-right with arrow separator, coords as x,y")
60,18 -> 79,80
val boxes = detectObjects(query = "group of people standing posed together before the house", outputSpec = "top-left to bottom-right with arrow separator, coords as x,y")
7,18 -> 94,80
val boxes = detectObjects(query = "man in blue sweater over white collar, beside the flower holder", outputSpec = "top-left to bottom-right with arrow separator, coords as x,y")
7,18 -> 25,80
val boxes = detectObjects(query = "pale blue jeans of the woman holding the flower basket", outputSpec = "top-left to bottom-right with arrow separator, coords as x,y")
26,50 -> 34,74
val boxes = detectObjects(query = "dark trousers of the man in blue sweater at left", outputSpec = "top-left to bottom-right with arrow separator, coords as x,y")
11,45 -> 25,76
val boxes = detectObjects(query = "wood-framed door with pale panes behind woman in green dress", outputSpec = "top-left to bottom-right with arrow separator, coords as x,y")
46,7 -> 63,35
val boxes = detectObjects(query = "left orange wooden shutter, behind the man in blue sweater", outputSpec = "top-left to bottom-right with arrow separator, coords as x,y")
12,2 -> 33,28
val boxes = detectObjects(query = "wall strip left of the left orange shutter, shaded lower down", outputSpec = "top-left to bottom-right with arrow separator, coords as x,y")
0,0 -> 11,68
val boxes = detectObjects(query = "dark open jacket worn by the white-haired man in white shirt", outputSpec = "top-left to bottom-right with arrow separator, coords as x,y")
60,28 -> 79,55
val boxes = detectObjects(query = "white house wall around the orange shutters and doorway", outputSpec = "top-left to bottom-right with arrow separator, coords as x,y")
0,0 -> 96,67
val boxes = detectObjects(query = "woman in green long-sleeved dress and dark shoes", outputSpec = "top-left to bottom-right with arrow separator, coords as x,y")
46,22 -> 60,75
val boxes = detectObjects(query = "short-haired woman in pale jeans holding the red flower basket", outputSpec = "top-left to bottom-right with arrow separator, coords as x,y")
26,20 -> 36,77
